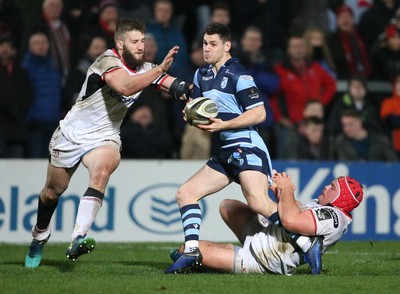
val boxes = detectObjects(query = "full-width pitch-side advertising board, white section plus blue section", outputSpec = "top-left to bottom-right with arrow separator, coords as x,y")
0,160 -> 400,243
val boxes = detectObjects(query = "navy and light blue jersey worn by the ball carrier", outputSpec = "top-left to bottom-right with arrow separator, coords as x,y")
192,58 -> 268,154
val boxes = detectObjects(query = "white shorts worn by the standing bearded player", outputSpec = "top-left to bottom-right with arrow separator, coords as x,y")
49,127 -> 121,168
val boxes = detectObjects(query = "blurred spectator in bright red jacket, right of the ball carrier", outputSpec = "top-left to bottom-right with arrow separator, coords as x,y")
271,36 -> 336,158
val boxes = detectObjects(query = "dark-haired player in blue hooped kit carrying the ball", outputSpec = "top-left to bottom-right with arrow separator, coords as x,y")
165,23 -> 321,274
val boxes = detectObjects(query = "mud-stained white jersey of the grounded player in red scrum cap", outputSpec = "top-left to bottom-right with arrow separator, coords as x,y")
250,202 -> 351,275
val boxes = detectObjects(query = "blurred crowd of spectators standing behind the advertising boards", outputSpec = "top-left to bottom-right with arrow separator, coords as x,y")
0,0 -> 400,161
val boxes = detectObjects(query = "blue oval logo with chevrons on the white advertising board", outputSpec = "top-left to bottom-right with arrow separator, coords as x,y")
129,183 -> 207,235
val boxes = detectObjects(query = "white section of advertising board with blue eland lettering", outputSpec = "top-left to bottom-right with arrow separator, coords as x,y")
0,160 -> 244,243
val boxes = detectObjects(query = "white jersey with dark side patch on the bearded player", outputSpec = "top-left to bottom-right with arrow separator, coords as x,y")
60,49 -> 163,144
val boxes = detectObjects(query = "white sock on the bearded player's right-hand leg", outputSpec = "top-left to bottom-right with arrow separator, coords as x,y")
71,196 -> 103,240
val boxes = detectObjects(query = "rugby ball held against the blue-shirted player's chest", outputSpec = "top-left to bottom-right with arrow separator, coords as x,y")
185,97 -> 218,126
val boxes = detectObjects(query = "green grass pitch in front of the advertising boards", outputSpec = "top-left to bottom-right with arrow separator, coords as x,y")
0,241 -> 400,294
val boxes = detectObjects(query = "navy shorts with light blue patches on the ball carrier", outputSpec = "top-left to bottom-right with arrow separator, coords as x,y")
207,147 -> 272,183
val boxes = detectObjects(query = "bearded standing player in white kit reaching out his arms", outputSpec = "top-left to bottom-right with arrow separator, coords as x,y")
25,19 -> 190,267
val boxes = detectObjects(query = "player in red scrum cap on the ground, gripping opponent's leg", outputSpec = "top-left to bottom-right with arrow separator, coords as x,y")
170,172 -> 363,275
